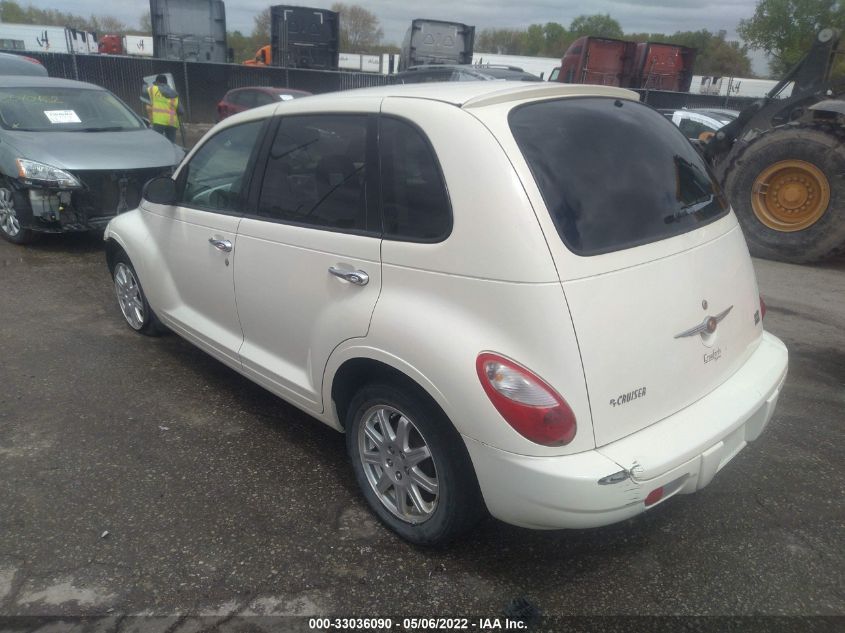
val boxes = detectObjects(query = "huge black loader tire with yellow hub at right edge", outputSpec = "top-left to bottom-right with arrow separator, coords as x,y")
725,125 -> 845,264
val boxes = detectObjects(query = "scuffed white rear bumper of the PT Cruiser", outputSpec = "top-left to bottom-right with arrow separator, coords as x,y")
464,332 -> 788,529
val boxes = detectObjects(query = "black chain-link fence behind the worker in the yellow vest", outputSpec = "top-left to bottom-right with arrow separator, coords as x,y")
14,52 -> 393,123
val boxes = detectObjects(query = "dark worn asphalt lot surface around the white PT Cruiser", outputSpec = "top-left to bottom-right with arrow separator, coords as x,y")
0,236 -> 845,632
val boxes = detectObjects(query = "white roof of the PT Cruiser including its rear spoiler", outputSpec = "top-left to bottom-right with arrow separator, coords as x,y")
300,81 -> 639,108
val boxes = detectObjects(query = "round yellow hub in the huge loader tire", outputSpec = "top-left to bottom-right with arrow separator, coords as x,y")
751,160 -> 830,233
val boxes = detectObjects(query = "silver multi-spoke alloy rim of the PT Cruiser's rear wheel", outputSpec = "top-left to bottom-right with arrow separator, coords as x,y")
357,405 -> 440,524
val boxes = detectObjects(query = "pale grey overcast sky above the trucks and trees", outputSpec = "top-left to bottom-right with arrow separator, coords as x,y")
34,0 -> 764,70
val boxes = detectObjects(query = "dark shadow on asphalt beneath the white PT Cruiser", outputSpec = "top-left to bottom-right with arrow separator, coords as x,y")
143,334 -> 672,560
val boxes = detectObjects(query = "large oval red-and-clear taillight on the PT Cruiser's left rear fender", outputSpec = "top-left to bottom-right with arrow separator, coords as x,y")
475,352 -> 577,446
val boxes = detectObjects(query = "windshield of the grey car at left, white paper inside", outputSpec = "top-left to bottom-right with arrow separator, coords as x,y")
0,87 -> 144,132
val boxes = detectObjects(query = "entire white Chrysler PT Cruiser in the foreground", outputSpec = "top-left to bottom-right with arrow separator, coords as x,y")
105,81 -> 787,543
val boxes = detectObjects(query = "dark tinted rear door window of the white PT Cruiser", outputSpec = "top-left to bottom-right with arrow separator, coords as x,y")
258,114 -> 368,231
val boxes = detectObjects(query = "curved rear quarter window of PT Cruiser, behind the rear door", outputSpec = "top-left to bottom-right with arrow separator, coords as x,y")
379,117 -> 452,242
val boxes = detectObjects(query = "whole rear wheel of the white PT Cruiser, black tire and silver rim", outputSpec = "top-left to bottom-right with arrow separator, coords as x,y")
346,384 -> 484,545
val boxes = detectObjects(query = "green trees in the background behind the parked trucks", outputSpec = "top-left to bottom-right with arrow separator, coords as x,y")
0,0 -> 845,77
